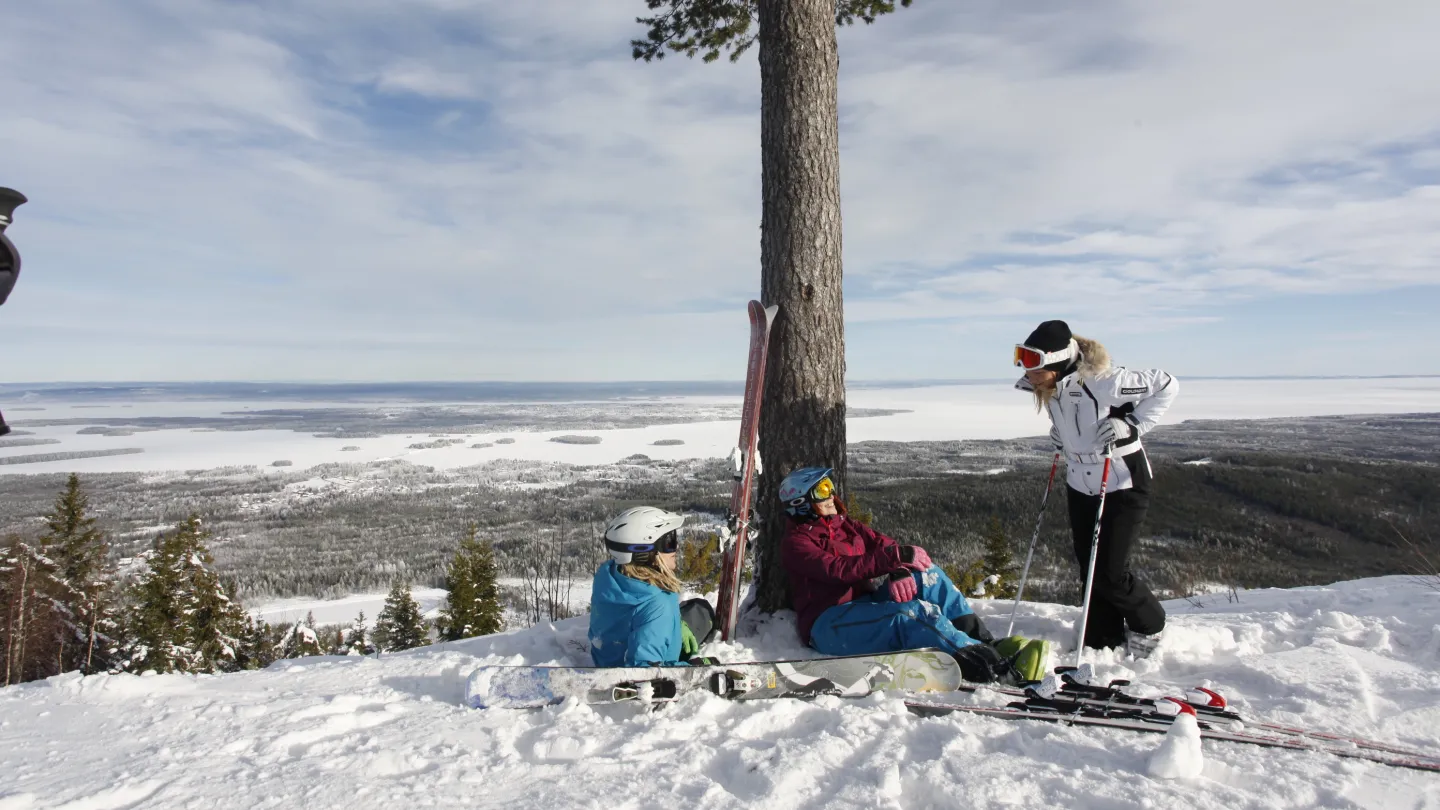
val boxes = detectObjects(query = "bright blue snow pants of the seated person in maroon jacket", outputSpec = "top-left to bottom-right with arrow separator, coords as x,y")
811,565 -> 979,656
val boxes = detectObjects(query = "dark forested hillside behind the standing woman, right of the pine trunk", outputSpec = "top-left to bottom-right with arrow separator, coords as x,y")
855,453 -> 1440,601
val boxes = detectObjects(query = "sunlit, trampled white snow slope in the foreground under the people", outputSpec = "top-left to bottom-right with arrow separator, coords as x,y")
0,577 -> 1440,810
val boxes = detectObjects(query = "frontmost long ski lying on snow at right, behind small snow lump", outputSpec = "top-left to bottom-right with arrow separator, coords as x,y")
906,690 -> 1440,773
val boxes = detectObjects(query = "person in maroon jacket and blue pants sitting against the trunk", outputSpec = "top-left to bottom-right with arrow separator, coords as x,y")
780,467 -> 1007,682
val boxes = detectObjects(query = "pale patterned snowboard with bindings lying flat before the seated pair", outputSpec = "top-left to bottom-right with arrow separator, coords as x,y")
465,650 -> 960,709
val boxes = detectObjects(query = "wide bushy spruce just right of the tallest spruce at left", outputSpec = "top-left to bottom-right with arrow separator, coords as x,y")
125,515 -> 251,672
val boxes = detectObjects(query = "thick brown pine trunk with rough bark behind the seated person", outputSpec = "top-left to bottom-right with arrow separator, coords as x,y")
755,0 -> 845,611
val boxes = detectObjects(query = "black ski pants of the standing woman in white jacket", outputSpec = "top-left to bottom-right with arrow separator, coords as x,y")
1066,451 -> 1165,649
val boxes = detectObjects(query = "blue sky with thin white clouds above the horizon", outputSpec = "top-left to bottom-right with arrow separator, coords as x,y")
0,0 -> 1440,380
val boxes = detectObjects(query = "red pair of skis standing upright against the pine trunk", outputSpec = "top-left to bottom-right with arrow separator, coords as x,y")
716,301 -> 779,641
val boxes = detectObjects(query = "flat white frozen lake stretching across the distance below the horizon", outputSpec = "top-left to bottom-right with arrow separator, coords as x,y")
0,378 -> 1440,474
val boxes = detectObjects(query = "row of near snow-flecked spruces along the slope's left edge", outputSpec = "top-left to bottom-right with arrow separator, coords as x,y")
0,476 -> 506,686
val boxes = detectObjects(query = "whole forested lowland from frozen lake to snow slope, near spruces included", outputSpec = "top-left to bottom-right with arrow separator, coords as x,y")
0,415 -> 1440,694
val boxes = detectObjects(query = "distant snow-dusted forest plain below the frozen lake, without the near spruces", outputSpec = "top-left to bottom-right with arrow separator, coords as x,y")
0,415 -> 1440,601
